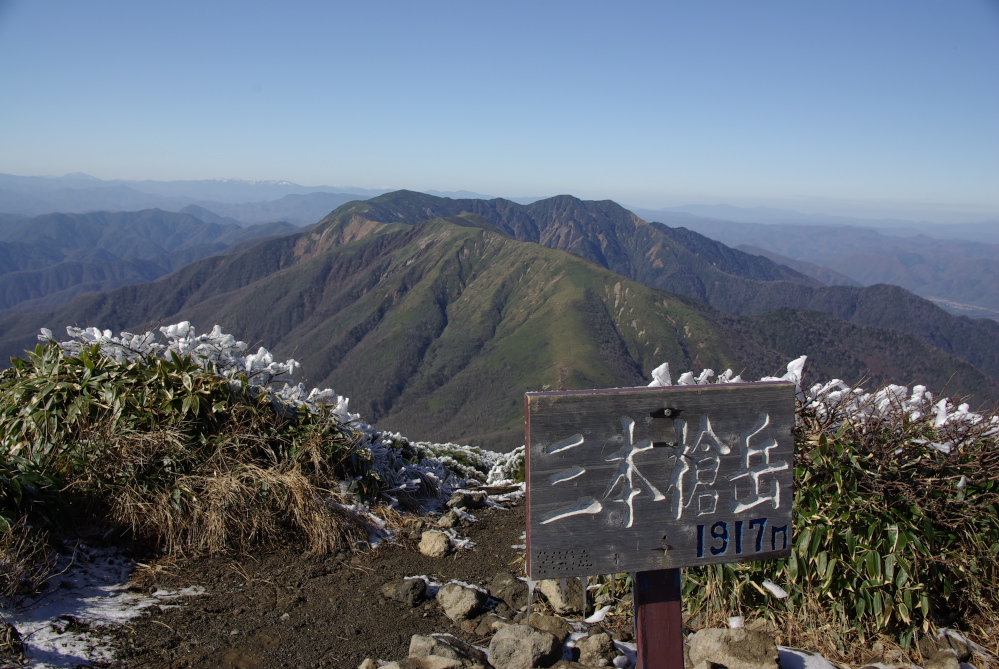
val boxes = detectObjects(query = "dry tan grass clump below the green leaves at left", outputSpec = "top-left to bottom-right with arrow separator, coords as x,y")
73,422 -> 367,557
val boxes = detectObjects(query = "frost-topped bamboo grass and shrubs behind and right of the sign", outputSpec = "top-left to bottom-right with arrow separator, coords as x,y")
653,357 -> 999,659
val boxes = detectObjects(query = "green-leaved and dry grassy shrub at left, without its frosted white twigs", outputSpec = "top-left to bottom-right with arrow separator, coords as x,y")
0,334 -> 376,554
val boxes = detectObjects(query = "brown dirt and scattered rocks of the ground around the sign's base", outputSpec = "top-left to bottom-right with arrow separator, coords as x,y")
0,494 -> 988,669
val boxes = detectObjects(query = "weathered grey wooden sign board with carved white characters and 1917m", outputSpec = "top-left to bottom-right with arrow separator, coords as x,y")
525,382 -> 795,579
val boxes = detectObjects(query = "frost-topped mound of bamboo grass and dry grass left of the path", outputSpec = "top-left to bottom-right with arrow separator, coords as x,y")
0,322 -> 498,595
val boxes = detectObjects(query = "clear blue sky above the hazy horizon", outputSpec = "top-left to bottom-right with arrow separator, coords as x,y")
0,0 -> 999,217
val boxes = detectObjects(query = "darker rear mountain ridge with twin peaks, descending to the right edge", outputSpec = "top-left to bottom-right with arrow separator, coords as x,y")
303,191 -> 999,378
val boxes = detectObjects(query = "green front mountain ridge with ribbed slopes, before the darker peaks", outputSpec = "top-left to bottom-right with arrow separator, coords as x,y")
0,209 -> 999,448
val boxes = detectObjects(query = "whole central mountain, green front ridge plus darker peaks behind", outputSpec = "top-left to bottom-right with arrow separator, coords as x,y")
0,191 -> 999,447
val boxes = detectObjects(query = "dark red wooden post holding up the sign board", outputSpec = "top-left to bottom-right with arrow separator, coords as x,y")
632,569 -> 683,669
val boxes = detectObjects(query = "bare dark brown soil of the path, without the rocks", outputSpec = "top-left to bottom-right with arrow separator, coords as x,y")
101,500 -> 620,669
